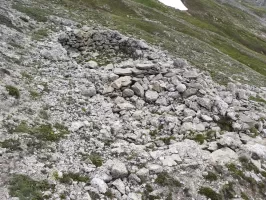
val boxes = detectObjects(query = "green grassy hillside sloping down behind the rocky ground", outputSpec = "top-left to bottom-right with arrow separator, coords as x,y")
11,0 -> 266,86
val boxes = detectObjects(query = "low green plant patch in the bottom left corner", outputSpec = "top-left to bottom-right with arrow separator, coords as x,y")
9,174 -> 54,200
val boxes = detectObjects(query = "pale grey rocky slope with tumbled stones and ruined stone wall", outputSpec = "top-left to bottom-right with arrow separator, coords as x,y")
0,0 -> 266,200
